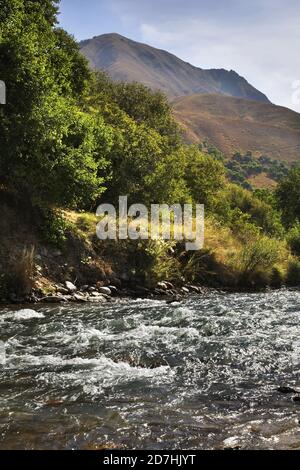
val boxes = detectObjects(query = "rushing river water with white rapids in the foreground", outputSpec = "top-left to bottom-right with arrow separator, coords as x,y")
0,290 -> 300,449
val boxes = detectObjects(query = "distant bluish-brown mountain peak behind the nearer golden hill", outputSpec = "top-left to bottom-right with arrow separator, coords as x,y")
80,34 -> 269,103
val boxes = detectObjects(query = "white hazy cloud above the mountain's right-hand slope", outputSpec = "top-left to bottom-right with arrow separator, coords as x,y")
140,11 -> 300,112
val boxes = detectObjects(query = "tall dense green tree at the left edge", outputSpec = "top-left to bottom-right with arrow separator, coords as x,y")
0,0 -> 110,207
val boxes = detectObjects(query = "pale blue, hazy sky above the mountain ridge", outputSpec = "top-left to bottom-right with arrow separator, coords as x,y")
59,0 -> 300,112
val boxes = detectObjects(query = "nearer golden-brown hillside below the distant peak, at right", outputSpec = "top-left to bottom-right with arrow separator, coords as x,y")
173,94 -> 300,163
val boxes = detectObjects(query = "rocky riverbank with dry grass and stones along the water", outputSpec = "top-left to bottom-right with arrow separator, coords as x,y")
0,198 -> 300,304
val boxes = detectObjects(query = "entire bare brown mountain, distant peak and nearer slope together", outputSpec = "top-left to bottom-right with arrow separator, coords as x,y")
80,34 -> 300,167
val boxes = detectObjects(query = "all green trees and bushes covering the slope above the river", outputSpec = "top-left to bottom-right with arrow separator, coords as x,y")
0,0 -> 300,291
